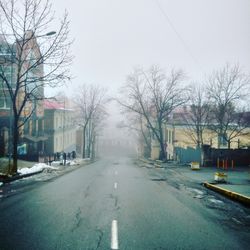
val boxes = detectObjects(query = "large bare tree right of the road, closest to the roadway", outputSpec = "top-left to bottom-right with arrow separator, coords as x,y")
118,66 -> 186,160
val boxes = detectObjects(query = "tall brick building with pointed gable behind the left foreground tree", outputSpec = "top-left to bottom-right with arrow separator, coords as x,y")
0,31 -> 47,160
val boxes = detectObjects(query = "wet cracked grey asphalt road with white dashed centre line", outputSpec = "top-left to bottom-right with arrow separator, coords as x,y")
0,158 -> 249,250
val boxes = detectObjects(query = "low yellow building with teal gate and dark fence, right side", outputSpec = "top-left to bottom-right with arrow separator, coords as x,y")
171,109 -> 250,166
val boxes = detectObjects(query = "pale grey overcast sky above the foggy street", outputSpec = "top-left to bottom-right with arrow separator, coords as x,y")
49,0 -> 250,96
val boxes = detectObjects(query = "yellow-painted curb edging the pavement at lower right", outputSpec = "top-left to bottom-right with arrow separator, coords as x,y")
203,182 -> 250,207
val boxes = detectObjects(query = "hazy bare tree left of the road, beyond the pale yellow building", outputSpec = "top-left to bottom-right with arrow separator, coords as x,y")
74,84 -> 107,158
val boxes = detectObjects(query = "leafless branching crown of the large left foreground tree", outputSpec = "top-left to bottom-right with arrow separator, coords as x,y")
0,0 -> 72,88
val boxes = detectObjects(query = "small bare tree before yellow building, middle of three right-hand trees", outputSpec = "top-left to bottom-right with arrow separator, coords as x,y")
182,85 -> 210,148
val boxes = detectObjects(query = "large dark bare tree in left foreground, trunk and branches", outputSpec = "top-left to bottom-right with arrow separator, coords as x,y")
0,0 -> 72,173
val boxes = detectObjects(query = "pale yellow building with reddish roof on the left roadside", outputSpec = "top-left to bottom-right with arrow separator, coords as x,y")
44,100 -> 76,155
